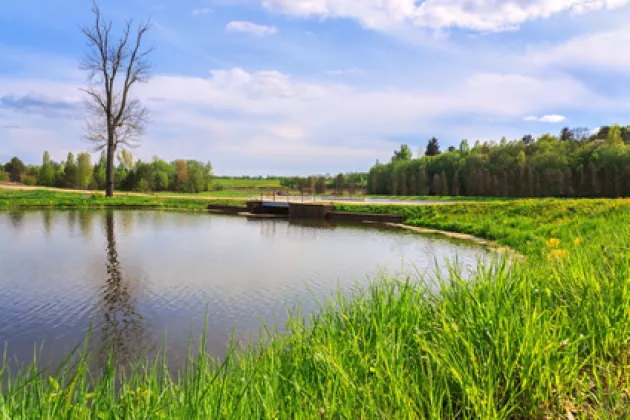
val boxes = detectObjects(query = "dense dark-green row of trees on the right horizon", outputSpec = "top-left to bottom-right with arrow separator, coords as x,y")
367,126 -> 630,197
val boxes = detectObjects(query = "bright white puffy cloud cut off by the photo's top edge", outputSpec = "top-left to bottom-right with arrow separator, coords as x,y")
260,0 -> 629,31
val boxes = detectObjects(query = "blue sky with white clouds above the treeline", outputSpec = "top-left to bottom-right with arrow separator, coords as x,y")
0,0 -> 630,176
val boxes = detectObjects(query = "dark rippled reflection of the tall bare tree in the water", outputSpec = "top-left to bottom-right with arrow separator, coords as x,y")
100,211 -> 143,370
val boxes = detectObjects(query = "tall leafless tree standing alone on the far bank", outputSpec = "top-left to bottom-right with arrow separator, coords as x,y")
81,1 -> 153,197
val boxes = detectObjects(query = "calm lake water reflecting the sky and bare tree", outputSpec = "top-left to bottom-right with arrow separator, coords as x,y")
0,210 -> 488,366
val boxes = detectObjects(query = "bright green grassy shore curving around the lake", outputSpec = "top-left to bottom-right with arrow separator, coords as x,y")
0,191 -> 630,419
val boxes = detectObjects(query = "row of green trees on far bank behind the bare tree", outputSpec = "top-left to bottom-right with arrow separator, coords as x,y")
0,150 -> 212,193
